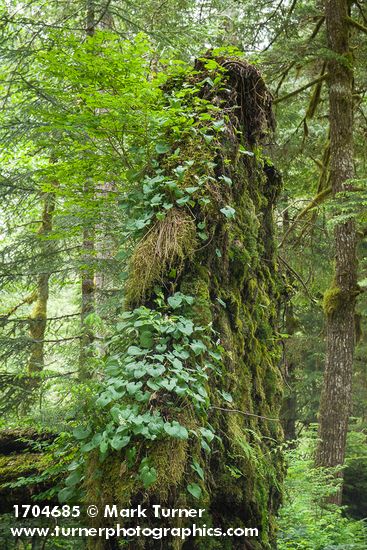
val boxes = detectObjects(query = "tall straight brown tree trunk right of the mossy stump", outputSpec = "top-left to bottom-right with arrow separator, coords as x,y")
316,0 -> 357,504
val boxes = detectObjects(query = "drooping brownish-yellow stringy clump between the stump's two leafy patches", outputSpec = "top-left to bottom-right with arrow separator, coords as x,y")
126,208 -> 196,305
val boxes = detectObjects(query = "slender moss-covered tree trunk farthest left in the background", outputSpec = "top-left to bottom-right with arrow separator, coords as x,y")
28,193 -> 55,384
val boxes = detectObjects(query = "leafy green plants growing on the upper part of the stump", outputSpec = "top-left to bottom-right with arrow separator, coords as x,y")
121,64 -> 225,238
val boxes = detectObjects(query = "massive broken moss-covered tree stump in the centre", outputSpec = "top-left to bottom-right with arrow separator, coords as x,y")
86,56 -> 283,550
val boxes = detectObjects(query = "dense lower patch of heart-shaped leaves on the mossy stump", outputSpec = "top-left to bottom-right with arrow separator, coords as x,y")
64,292 -> 221,501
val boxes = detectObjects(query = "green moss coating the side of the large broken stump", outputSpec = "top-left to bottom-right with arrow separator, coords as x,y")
85,54 -> 284,550
